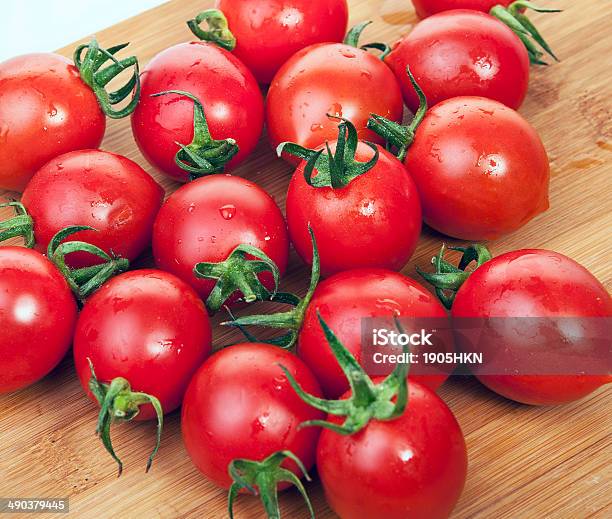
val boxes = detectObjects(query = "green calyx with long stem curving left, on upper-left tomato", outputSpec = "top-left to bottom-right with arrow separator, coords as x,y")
151,90 -> 239,180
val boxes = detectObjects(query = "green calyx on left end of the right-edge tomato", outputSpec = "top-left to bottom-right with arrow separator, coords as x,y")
417,243 -> 491,310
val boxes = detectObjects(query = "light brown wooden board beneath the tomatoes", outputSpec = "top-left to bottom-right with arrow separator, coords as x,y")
0,0 -> 612,519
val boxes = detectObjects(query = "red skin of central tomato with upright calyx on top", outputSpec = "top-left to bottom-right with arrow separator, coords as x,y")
286,142 -> 421,276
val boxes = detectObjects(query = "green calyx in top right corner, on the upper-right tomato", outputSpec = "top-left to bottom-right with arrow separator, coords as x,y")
489,0 -> 561,65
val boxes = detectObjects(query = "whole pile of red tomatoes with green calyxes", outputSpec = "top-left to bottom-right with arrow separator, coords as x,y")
0,0 -> 612,519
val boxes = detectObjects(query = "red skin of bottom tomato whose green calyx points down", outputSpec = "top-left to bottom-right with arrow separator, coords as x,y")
181,343 -> 325,488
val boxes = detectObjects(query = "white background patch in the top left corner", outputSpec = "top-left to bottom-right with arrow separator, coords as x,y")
0,0 -> 164,61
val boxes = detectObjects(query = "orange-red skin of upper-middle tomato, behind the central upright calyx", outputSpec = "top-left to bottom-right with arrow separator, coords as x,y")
266,43 -> 404,164
